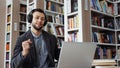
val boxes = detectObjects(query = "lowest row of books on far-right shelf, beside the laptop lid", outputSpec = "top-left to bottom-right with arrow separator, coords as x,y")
95,46 -> 116,59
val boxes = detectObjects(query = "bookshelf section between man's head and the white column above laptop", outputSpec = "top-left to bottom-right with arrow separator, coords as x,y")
44,0 -> 64,47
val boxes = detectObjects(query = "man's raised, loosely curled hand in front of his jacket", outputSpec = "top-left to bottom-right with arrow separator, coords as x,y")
22,39 -> 32,57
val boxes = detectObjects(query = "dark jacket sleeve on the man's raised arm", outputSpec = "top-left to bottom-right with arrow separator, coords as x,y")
11,37 -> 25,68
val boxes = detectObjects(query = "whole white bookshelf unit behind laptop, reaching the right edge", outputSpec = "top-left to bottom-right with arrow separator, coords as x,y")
64,0 -> 120,65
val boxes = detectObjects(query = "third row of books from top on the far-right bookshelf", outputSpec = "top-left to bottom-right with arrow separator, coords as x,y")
92,32 -> 114,43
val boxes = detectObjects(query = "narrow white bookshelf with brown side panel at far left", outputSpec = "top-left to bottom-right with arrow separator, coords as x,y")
4,0 -> 19,68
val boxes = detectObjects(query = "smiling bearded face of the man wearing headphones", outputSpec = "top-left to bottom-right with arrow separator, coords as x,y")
32,12 -> 45,30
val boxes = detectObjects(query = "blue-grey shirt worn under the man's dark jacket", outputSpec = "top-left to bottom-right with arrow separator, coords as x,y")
32,32 -> 49,68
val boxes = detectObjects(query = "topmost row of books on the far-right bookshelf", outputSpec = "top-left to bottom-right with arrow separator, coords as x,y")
90,0 -> 114,15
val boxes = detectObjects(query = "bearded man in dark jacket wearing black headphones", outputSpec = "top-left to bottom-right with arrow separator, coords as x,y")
11,9 -> 59,68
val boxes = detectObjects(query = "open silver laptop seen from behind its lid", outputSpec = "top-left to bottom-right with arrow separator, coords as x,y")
57,42 -> 97,68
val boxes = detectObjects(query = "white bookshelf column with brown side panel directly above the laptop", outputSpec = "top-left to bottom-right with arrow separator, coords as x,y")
64,0 -> 91,42
